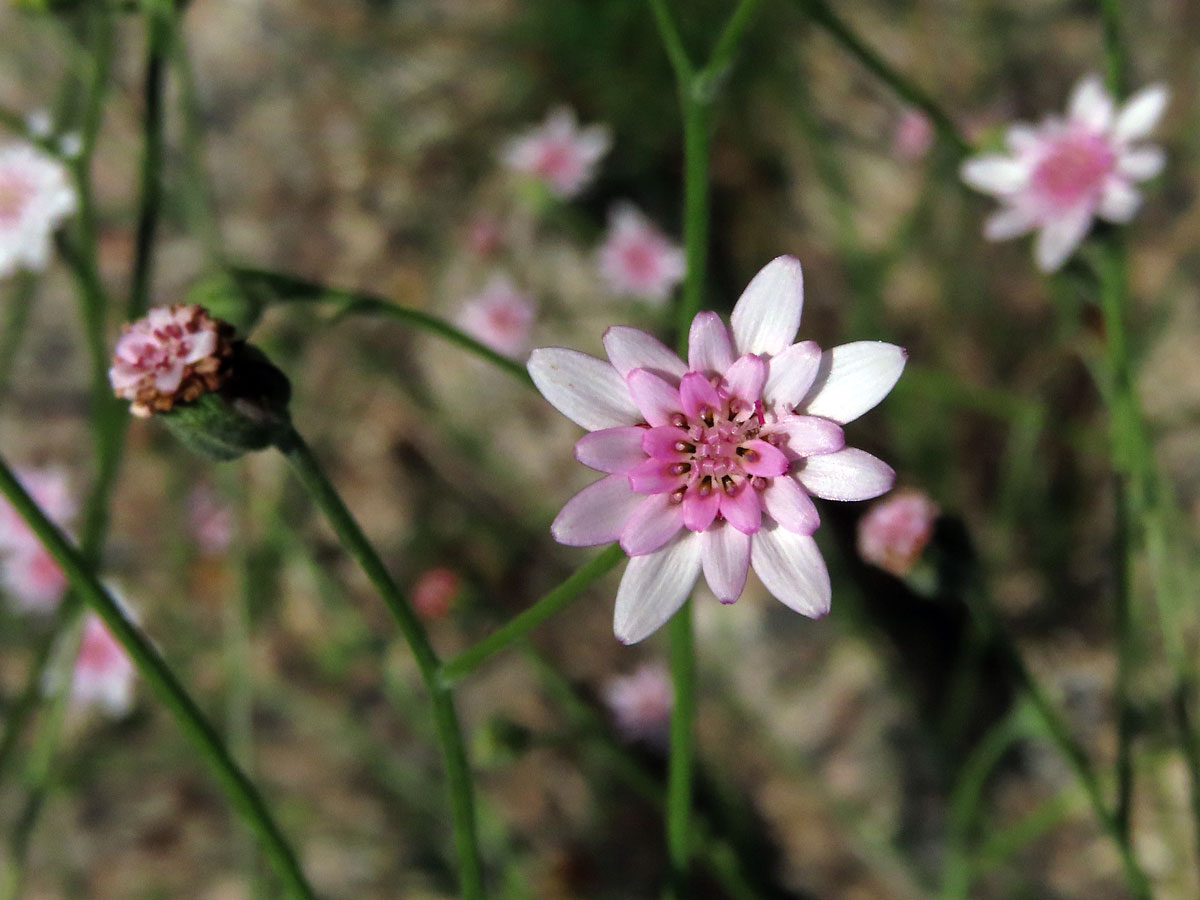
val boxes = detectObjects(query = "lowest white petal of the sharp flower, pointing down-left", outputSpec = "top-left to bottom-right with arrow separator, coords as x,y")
612,530 -> 703,643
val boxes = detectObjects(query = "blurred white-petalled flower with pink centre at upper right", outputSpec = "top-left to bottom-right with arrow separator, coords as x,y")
961,77 -> 1168,271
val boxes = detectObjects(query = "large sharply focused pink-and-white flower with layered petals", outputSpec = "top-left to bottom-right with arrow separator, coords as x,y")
529,257 -> 907,643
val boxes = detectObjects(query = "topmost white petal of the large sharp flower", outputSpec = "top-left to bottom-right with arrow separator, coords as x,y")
730,257 -> 804,356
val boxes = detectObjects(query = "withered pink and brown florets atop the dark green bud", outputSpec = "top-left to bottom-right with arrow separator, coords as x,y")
108,305 -> 232,419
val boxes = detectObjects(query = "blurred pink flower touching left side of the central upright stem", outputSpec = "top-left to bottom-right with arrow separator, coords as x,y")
596,203 -> 686,302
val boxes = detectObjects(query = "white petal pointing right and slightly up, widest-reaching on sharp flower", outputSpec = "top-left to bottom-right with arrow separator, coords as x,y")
796,341 -> 908,425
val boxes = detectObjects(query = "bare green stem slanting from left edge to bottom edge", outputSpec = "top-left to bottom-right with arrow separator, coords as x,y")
0,458 -> 316,900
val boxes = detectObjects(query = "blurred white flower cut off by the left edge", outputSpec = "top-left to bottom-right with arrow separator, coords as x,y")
0,144 -> 76,277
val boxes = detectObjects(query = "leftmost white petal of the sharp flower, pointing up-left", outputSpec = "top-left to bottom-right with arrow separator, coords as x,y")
526,347 -> 642,431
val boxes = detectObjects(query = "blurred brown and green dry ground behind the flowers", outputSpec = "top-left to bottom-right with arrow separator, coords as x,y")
0,0 -> 1200,900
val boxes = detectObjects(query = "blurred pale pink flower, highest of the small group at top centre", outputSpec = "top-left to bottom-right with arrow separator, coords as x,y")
500,107 -> 612,199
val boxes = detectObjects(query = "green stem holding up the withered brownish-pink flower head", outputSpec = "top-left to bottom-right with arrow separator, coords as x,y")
277,428 -> 485,900
